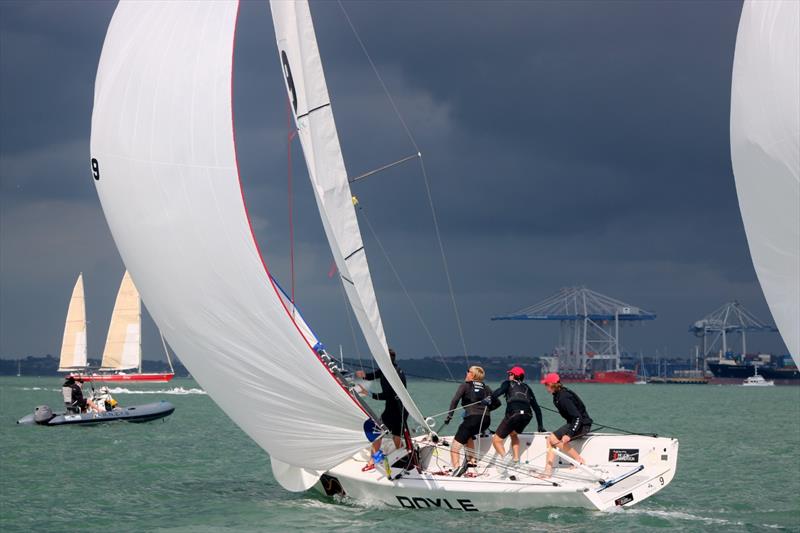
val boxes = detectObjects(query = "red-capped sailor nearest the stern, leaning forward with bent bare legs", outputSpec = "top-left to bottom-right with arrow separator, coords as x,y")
542,372 -> 592,477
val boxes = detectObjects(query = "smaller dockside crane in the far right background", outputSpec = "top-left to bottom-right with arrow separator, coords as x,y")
689,300 -> 778,360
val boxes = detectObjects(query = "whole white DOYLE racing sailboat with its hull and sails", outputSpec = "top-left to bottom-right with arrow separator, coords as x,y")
90,1 -> 678,511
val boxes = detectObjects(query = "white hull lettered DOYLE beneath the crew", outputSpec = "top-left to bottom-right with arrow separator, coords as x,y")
315,433 -> 678,512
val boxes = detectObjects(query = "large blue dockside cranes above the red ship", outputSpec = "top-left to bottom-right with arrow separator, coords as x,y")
492,287 -> 656,375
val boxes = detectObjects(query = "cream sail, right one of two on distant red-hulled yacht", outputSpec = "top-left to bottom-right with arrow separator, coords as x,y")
100,270 -> 142,370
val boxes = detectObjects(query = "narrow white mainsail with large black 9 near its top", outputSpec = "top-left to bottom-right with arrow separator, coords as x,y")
270,0 -> 427,427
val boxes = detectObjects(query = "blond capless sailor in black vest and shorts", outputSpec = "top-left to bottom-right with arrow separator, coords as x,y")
444,366 -> 500,477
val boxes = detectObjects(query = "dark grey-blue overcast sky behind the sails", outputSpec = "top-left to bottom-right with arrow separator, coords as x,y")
0,0 -> 787,364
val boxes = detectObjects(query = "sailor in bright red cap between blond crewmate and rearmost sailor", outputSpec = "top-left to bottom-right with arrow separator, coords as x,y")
483,366 -> 545,472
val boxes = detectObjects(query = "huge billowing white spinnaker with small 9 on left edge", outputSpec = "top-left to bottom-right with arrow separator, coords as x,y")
91,0 -> 368,470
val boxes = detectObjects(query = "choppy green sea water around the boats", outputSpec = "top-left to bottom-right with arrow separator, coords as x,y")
0,376 -> 800,532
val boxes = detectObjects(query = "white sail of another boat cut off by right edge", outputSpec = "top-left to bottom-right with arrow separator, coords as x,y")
731,0 -> 800,366
